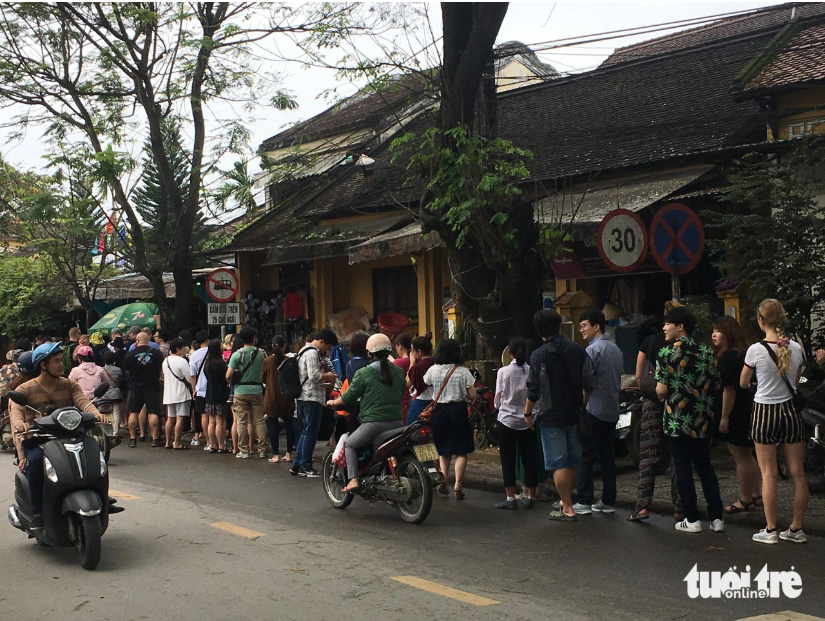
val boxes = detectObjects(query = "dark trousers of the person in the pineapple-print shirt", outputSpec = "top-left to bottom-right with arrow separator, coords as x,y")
668,438 -> 724,522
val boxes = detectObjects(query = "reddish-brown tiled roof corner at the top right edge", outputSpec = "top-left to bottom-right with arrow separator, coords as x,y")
745,24 -> 825,92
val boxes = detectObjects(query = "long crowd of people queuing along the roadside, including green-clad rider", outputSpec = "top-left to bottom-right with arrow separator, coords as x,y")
0,299 -> 825,544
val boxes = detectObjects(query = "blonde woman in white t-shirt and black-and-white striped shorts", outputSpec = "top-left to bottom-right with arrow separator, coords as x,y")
740,299 -> 808,543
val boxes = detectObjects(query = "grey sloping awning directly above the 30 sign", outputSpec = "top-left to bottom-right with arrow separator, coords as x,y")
534,165 -> 714,224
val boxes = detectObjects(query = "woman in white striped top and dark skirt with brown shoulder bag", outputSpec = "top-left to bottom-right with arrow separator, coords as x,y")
424,339 -> 476,500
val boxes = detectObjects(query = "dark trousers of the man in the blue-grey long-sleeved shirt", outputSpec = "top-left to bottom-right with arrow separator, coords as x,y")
576,414 -> 616,507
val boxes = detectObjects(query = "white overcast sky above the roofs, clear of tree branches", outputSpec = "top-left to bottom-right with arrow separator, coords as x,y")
0,2 -> 777,185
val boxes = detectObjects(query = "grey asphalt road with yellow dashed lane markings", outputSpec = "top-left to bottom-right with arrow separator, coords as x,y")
0,444 -> 825,621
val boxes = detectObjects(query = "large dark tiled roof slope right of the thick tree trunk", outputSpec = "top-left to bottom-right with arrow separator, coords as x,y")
498,33 -> 773,180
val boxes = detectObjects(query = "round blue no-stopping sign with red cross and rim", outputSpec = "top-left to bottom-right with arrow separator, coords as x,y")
650,203 -> 705,276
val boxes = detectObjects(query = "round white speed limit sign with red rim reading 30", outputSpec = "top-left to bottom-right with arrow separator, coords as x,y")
596,209 -> 648,273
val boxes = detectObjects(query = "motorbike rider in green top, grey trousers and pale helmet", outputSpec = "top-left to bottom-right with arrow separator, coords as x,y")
327,334 -> 407,492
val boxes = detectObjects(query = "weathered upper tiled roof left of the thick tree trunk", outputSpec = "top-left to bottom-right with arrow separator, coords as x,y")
259,74 -> 432,152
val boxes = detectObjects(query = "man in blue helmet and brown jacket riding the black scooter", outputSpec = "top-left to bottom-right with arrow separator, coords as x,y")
11,343 -> 106,528
